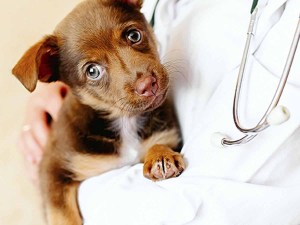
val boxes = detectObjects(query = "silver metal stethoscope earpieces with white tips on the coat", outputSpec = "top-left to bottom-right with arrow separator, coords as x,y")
211,0 -> 300,147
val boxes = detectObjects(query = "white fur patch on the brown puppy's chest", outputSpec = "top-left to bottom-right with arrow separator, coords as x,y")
114,117 -> 141,164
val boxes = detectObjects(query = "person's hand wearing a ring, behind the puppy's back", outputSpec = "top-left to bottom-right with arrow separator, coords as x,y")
18,82 -> 68,184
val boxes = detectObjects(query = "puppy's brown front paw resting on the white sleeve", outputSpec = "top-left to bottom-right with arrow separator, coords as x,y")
144,145 -> 185,181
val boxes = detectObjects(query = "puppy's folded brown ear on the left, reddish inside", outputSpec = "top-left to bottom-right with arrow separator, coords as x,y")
12,36 -> 59,92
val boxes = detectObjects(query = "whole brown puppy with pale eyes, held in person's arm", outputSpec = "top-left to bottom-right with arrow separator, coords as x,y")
13,0 -> 185,225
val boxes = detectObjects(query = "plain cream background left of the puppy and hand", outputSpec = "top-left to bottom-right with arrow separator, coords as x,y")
0,0 -> 80,225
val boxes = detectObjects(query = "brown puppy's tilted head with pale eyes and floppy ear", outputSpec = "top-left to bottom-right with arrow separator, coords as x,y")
13,0 -> 169,115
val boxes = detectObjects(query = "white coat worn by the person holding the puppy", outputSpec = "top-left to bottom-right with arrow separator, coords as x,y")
79,0 -> 300,225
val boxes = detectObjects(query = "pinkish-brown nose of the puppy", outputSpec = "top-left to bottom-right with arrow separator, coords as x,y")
135,75 -> 158,97
